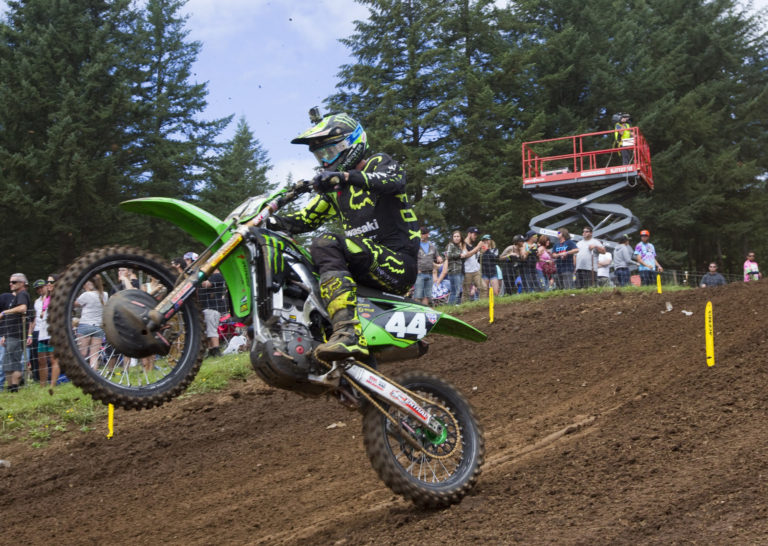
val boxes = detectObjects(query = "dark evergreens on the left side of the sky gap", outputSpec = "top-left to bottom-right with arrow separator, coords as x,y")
0,0 -> 270,276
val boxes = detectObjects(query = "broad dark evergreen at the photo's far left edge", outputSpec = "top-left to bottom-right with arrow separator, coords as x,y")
0,0 -> 133,276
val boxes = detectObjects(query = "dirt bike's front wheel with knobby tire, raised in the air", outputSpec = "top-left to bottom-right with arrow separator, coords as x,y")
48,247 -> 204,409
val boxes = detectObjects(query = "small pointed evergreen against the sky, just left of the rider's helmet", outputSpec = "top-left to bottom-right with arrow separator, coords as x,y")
200,118 -> 276,218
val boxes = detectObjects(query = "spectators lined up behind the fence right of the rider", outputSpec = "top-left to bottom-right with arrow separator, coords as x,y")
412,226 -> 762,305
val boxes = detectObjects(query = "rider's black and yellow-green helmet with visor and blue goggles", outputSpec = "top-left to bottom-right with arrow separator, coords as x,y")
291,114 -> 368,172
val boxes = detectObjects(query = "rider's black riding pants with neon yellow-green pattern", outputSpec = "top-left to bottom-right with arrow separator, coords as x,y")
309,233 -> 417,294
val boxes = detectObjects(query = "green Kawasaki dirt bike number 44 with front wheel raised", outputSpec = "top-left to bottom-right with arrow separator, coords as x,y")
49,181 -> 486,507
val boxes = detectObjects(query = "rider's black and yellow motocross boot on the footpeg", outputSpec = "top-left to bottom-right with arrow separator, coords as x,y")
315,271 -> 368,362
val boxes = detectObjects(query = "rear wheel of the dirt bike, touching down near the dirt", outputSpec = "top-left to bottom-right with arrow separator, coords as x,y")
363,371 -> 485,508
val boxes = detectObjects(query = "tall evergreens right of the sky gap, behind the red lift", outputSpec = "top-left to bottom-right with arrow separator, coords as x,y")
327,0 -> 768,271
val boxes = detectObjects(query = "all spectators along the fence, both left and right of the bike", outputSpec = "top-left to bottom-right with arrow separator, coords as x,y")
0,234 -> 762,393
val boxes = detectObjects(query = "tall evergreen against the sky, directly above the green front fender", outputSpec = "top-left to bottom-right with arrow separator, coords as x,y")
127,0 -> 232,255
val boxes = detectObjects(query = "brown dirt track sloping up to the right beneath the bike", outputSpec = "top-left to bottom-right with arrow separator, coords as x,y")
0,281 -> 768,544
